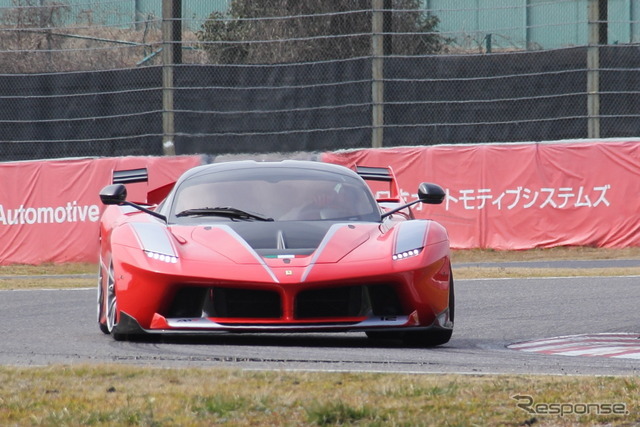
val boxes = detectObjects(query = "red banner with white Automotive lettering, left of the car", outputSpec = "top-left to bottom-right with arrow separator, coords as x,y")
0,156 -> 201,265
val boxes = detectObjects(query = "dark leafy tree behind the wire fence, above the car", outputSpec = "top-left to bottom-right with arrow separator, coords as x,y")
197,0 -> 447,64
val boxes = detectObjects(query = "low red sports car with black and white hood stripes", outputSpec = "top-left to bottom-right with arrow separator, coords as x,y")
98,161 -> 454,346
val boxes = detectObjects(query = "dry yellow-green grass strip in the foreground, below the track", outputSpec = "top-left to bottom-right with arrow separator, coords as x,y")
0,365 -> 640,426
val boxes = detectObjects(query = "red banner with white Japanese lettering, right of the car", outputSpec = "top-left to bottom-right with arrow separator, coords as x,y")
323,140 -> 640,250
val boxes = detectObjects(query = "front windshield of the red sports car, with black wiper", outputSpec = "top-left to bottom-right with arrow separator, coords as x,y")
170,167 -> 380,223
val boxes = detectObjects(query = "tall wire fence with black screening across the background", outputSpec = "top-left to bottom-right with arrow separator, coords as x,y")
0,0 -> 640,161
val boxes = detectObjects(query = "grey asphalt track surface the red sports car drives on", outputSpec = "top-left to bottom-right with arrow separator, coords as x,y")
0,270 -> 640,375
